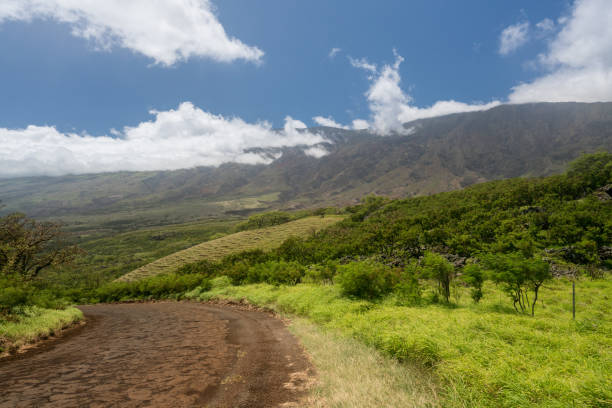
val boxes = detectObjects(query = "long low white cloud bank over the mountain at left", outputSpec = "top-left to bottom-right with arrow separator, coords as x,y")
0,102 -> 326,177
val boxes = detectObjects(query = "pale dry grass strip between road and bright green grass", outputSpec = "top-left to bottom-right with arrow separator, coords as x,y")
289,318 -> 439,408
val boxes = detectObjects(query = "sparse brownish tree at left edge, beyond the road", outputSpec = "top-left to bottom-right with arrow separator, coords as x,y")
0,213 -> 82,280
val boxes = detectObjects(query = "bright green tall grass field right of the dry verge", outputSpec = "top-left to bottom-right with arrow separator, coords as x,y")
189,277 -> 612,407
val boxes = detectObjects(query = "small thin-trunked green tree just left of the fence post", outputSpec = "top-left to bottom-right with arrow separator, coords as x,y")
482,254 -> 552,316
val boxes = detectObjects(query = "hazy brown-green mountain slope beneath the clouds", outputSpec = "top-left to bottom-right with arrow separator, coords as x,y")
0,103 -> 612,230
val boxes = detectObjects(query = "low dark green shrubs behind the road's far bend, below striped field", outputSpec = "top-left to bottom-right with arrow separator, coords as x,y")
93,274 -> 211,302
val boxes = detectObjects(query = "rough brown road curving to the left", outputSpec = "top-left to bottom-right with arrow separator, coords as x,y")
0,302 -> 312,408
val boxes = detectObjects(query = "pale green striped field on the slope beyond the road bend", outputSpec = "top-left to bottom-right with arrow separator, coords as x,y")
117,215 -> 342,281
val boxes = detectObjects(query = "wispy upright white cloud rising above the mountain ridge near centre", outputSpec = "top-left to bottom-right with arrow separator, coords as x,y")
340,51 -> 500,135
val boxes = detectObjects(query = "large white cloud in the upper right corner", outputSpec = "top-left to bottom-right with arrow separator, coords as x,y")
509,0 -> 612,103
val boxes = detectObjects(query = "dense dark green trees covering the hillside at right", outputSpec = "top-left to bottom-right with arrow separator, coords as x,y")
279,153 -> 612,267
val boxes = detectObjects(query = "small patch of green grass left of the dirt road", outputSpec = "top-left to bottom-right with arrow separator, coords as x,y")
0,306 -> 83,354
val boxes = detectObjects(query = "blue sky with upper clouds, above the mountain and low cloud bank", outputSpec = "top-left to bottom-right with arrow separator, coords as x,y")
0,0 -> 612,175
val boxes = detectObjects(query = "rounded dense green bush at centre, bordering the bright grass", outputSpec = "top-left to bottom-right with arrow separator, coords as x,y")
335,261 -> 397,299
